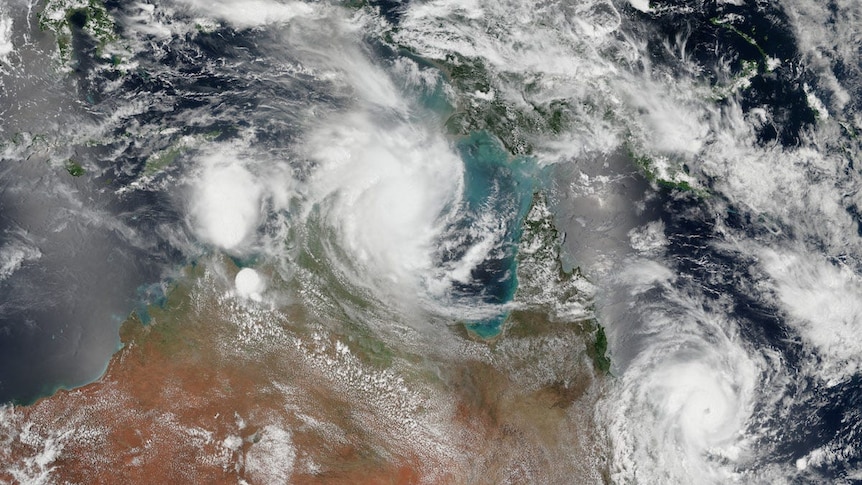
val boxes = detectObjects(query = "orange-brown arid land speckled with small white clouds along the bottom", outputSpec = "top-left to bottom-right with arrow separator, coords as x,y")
0,255 -> 606,484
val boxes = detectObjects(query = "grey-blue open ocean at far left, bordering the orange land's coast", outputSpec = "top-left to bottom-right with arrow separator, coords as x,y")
0,155 -> 180,402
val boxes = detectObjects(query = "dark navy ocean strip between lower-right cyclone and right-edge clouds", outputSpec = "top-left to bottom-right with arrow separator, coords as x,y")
652,191 -> 862,476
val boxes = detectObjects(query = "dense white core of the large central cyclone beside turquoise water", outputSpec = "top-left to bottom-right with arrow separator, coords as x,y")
306,113 -> 463,291
